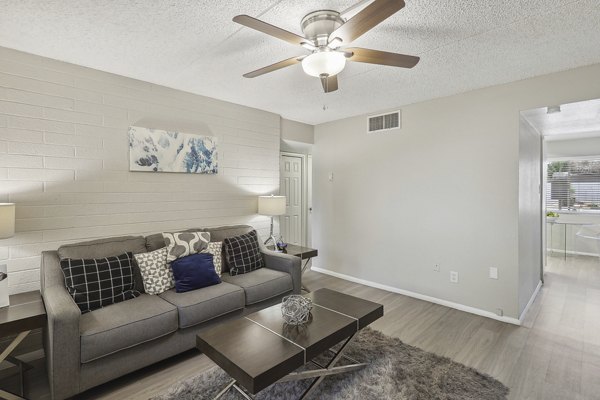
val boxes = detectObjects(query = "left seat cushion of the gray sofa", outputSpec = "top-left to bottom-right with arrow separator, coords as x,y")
79,294 -> 177,363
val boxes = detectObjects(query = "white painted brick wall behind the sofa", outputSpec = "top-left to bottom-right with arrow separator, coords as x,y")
0,47 -> 280,293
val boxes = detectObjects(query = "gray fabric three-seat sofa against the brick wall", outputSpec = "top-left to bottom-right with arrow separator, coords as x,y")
41,225 -> 301,399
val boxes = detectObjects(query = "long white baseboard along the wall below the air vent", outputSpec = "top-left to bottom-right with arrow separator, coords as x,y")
311,267 -> 521,325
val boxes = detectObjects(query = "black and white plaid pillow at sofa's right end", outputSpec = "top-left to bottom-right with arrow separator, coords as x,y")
223,231 -> 264,276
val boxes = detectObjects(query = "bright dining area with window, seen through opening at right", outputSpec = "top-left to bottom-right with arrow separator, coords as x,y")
522,99 -> 600,262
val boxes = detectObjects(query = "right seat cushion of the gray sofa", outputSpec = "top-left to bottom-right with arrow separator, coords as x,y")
221,268 -> 293,305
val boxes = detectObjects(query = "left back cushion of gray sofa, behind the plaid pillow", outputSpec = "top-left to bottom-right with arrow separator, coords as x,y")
58,236 -> 146,292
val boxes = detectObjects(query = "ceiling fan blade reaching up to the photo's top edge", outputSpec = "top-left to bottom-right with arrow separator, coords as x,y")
328,0 -> 405,44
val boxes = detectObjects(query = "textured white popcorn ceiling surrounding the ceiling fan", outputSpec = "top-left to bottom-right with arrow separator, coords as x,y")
0,0 -> 600,124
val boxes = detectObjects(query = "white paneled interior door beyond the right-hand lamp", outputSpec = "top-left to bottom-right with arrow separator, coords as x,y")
279,155 -> 303,246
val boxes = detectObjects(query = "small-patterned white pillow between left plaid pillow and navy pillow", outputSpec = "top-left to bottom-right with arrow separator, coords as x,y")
134,247 -> 175,294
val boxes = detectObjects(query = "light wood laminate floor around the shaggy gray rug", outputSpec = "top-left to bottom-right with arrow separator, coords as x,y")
8,257 -> 600,400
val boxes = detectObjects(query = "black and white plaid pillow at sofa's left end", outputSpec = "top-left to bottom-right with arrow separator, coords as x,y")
60,253 -> 140,313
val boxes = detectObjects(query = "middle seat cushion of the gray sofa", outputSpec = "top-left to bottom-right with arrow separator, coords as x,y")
159,282 -> 244,328
